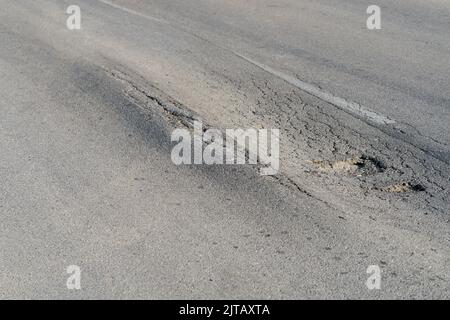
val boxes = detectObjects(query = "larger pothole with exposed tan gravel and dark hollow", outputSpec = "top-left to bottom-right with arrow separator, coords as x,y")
312,155 -> 386,176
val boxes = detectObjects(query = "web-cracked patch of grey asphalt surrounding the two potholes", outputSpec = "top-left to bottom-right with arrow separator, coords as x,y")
244,75 -> 450,219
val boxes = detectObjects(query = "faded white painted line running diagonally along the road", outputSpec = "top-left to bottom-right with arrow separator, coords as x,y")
97,0 -> 395,125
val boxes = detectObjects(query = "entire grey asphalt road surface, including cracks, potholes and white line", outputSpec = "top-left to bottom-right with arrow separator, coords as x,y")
0,0 -> 450,299
